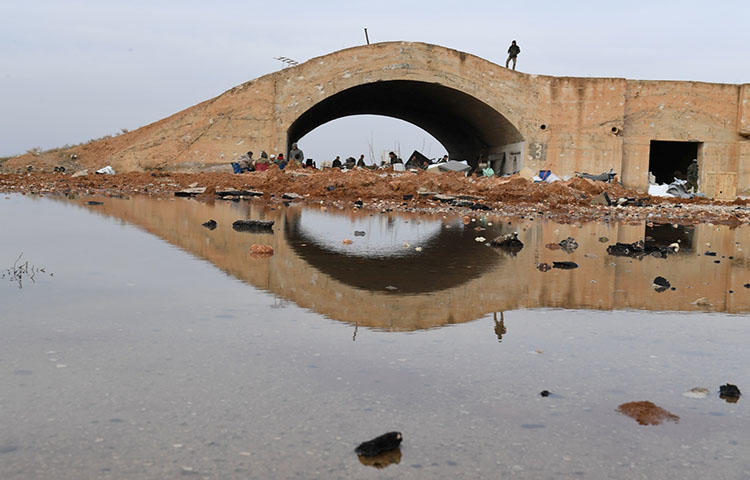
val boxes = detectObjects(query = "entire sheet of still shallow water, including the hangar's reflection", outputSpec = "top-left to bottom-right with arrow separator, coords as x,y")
0,196 -> 750,479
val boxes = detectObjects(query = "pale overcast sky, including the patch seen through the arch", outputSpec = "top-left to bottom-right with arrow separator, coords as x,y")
0,0 -> 750,160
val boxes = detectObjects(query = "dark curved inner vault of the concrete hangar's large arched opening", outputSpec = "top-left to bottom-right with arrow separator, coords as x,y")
287,80 -> 524,173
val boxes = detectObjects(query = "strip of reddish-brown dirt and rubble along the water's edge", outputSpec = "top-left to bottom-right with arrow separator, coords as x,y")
0,168 -> 750,226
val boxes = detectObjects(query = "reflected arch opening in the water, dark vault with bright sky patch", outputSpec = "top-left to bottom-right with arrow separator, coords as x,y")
284,209 -> 502,294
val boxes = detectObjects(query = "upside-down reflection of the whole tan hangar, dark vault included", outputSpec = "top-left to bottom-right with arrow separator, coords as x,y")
79,198 -> 750,330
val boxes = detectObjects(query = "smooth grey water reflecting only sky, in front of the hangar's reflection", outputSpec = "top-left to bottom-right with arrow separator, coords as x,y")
0,196 -> 750,479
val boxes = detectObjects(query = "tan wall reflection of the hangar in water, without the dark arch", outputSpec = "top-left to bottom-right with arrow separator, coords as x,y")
75,197 -> 750,330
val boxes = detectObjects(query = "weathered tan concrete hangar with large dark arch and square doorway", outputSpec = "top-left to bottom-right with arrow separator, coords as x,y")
82,42 -> 750,198
